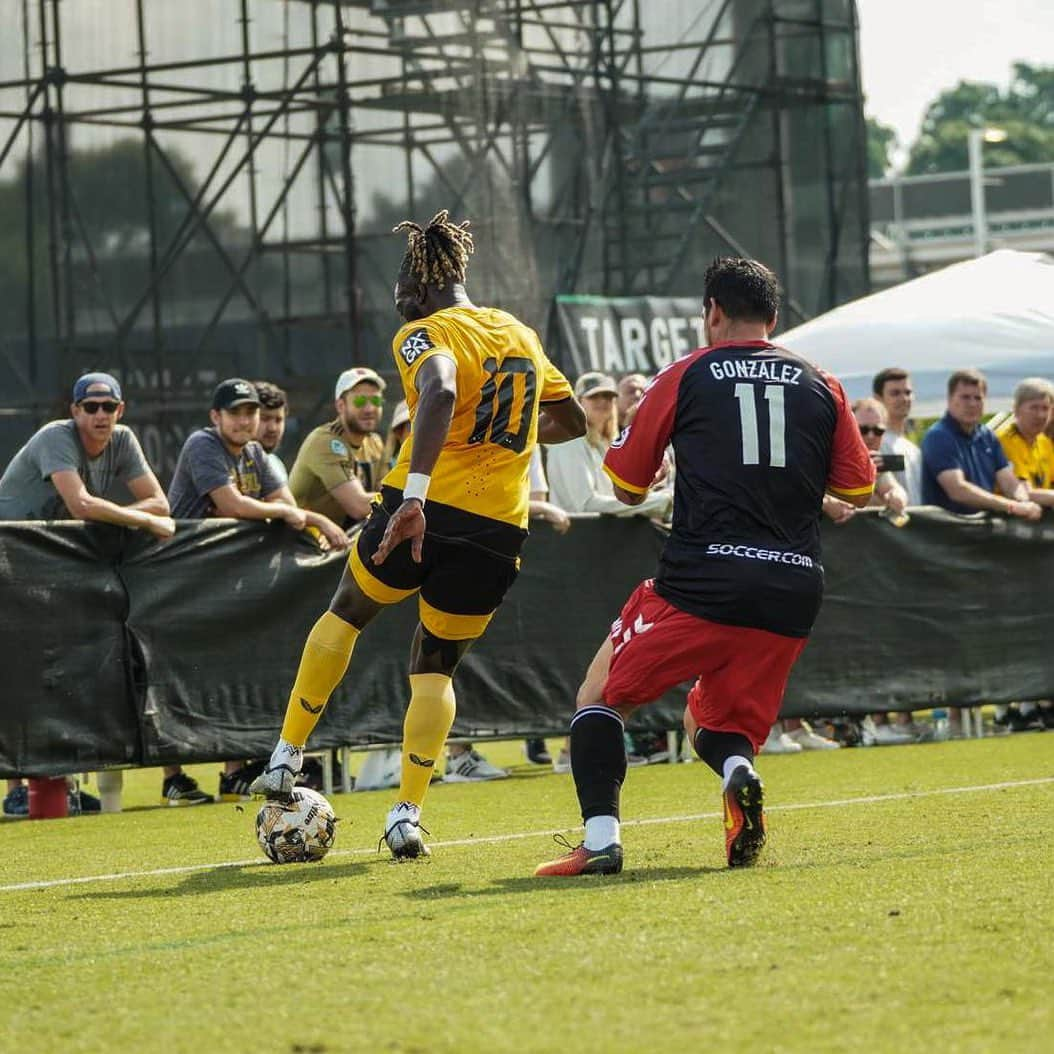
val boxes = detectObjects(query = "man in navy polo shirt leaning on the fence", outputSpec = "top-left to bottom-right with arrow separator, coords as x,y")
922,370 -> 1042,520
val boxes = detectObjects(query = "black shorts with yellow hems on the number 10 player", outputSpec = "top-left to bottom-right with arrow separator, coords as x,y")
348,487 -> 527,641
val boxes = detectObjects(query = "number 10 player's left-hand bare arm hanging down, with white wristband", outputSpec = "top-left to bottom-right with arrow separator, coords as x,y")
371,355 -> 457,566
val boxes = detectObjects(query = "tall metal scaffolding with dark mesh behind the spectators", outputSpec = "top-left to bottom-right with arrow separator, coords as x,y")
0,0 -> 867,463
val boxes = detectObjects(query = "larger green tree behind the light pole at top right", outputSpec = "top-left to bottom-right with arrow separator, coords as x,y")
906,62 -> 1054,175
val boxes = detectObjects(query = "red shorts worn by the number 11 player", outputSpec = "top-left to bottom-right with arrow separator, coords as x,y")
604,579 -> 805,752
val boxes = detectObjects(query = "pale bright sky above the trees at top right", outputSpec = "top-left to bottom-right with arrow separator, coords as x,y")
857,0 -> 1054,158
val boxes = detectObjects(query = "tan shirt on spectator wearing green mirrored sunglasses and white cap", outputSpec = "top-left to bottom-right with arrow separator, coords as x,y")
289,419 -> 385,526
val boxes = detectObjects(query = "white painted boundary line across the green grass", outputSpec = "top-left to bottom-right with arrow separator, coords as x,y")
0,776 -> 1054,893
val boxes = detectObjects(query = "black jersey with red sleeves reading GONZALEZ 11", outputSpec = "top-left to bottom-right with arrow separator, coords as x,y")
604,340 -> 875,637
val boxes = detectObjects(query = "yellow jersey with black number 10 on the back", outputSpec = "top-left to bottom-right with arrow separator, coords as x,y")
384,308 -> 572,528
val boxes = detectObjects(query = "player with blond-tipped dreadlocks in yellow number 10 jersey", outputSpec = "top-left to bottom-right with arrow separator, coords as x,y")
252,211 -> 585,860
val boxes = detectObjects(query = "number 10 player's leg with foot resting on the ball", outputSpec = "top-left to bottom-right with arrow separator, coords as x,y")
250,548 -> 387,801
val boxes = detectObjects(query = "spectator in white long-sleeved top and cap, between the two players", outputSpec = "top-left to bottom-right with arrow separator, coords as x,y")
546,373 -> 671,519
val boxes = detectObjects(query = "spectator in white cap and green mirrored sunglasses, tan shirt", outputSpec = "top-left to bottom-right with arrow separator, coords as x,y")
289,366 -> 387,527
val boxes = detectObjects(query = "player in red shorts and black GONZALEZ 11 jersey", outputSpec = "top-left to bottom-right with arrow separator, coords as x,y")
535,257 -> 875,876
